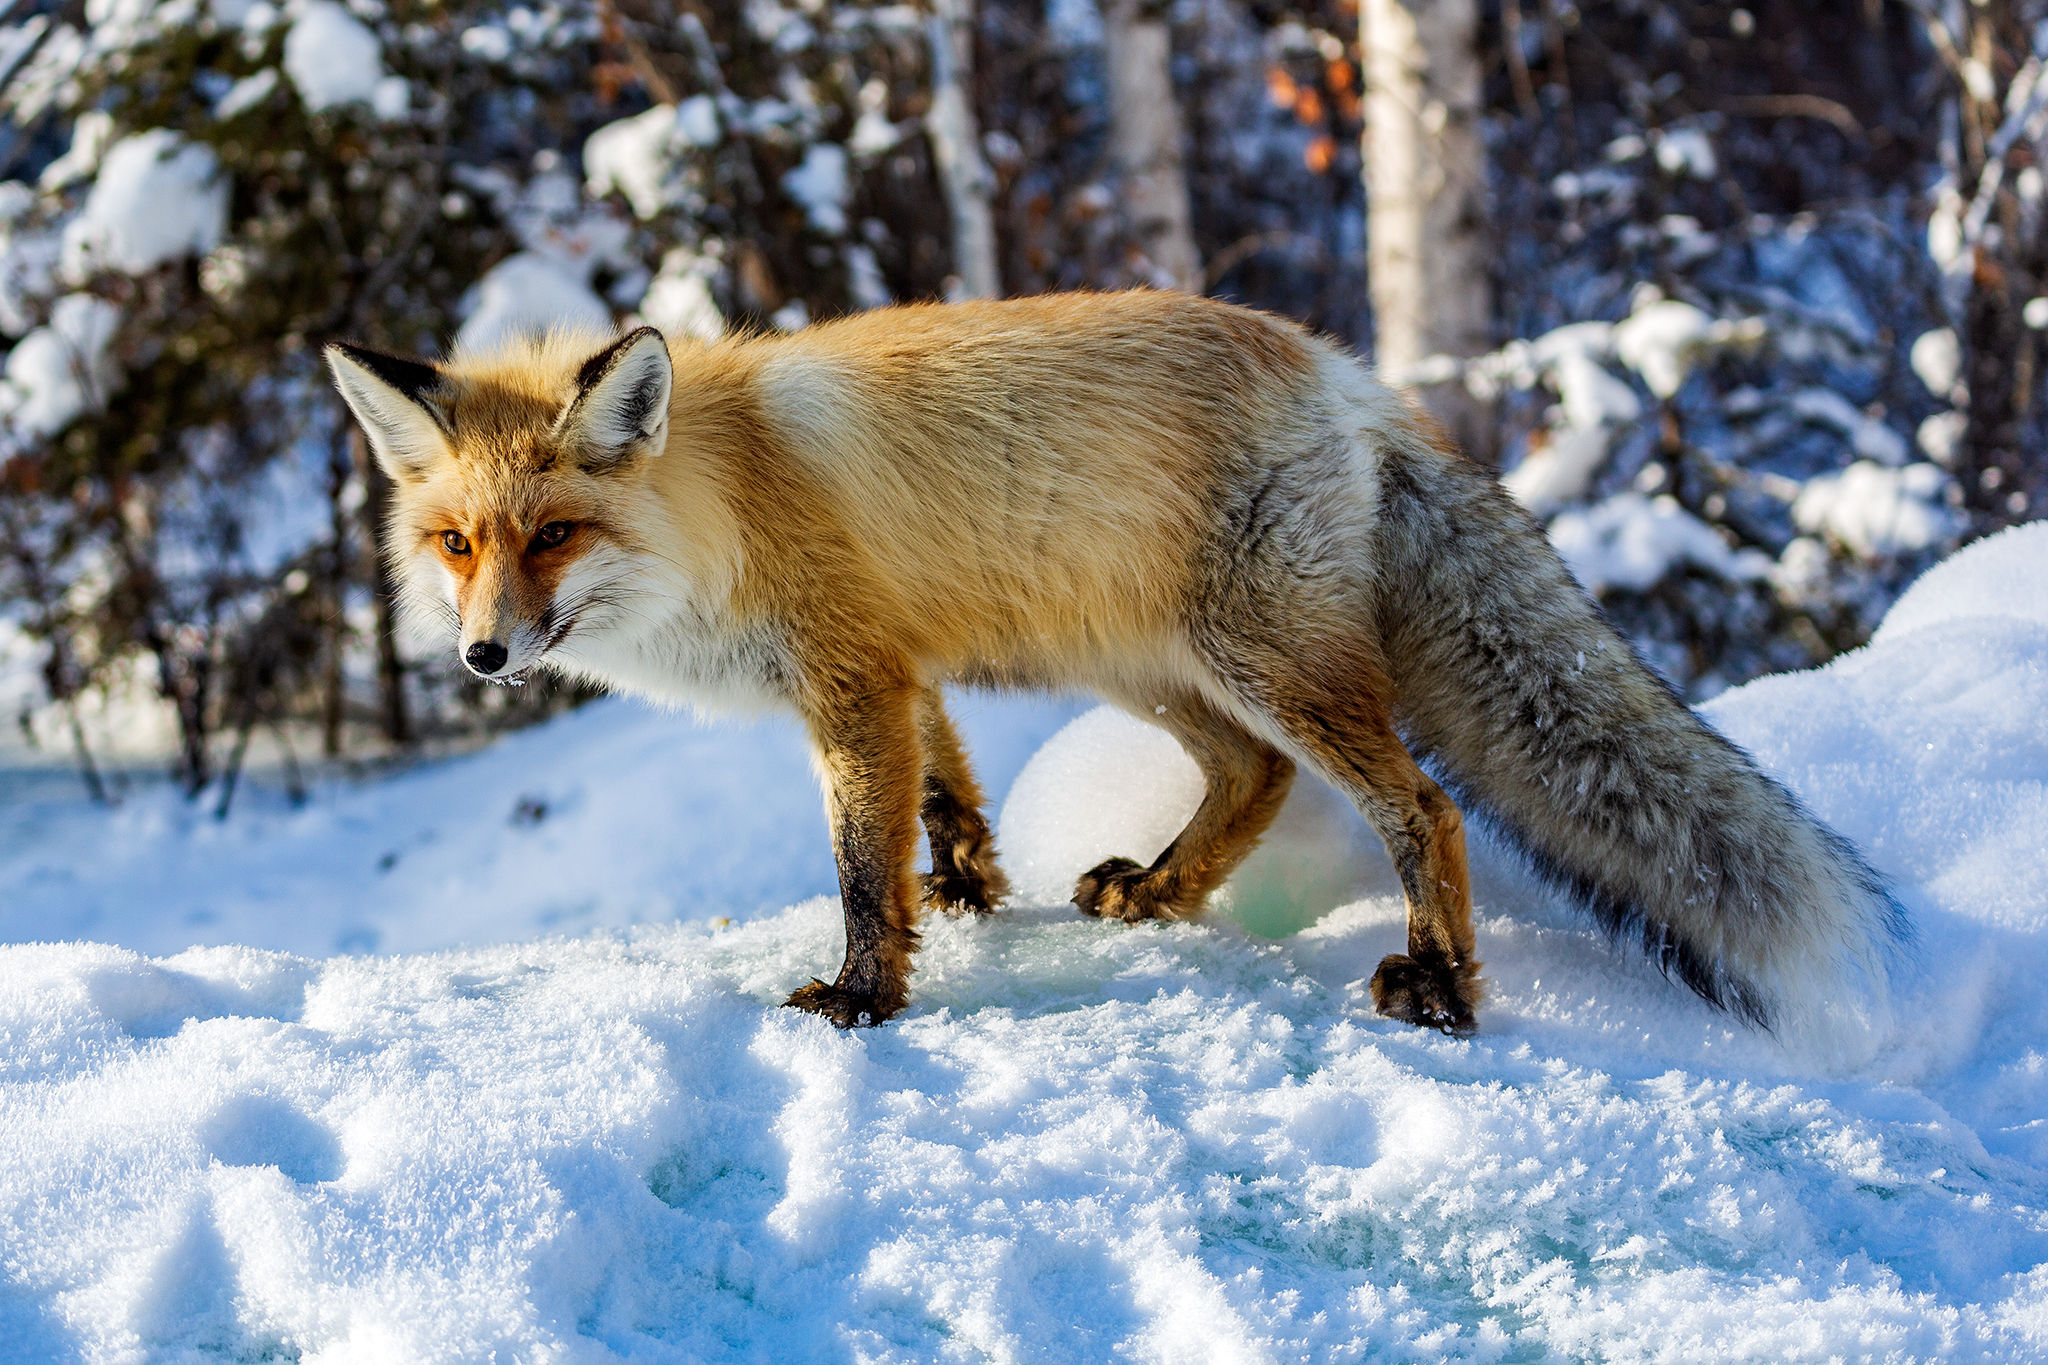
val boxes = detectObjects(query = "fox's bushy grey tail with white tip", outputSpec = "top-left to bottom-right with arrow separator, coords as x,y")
1378,437 -> 1909,1027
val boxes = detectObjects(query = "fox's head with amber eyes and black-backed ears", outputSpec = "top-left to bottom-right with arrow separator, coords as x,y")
328,327 -> 674,684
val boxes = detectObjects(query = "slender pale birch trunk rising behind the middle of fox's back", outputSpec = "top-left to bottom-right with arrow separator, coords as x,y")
1102,0 -> 1204,295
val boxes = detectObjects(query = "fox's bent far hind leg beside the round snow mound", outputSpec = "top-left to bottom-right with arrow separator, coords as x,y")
1073,694 -> 1294,921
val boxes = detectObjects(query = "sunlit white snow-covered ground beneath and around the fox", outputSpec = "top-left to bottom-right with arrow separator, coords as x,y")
0,526 -> 2048,1363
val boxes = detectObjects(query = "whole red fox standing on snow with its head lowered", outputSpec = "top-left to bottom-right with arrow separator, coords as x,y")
328,291 -> 1905,1033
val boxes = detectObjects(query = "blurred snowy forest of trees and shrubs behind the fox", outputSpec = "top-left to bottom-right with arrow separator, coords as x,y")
0,0 -> 2048,802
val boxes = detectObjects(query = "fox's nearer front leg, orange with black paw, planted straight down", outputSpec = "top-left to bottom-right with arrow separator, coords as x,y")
786,684 -> 924,1027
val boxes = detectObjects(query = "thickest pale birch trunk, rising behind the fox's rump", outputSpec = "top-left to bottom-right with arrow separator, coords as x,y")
1360,0 -> 1493,458
